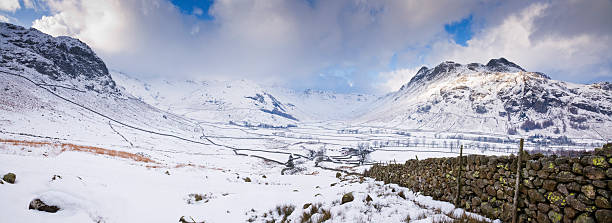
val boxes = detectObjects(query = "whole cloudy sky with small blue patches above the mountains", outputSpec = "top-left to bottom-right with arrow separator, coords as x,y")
0,0 -> 612,93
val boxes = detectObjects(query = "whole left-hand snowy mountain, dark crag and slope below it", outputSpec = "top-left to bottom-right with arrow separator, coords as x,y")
0,23 -> 199,147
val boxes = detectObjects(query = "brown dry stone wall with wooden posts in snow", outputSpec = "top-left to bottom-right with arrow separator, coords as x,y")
365,144 -> 612,223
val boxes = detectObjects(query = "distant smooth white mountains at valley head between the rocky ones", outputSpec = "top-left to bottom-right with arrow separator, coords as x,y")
111,71 -> 376,124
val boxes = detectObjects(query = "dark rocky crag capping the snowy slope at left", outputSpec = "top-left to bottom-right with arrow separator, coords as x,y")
0,23 -> 116,92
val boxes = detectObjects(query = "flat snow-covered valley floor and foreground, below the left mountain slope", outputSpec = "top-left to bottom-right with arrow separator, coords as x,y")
0,121 -> 506,222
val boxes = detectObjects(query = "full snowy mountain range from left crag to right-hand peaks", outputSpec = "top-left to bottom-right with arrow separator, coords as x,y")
0,20 -> 612,139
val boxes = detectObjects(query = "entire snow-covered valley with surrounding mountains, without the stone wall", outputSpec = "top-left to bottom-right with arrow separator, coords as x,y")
0,23 -> 612,222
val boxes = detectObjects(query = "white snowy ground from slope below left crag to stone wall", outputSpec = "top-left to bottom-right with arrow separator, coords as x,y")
0,68 -> 502,222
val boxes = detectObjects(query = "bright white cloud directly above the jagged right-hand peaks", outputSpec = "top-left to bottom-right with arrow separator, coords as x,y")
427,2 -> 612,82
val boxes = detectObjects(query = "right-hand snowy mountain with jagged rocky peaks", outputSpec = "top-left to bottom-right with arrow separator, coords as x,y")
359,58 -> 612,139
